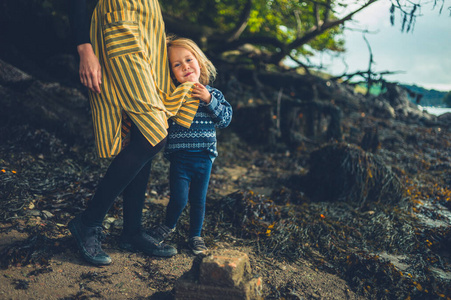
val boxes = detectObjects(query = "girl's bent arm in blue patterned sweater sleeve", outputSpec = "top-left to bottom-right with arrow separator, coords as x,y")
201,88 -> 233,128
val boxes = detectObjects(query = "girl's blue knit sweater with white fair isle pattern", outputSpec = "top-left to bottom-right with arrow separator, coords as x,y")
164,85 -> 232,157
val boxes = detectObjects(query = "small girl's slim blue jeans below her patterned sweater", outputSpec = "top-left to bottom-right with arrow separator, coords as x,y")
165,151 -> 213,238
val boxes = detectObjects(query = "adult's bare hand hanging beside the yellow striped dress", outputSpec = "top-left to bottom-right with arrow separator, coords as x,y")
77,43 -> 102,93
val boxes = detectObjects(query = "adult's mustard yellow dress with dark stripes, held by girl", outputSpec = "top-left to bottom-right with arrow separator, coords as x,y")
90,0 -> 199,157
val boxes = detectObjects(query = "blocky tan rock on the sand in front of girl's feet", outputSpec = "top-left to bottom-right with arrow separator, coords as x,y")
175,250 -> 262,300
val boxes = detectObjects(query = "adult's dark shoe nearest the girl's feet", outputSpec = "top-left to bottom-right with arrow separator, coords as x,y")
119,232 -> 177,257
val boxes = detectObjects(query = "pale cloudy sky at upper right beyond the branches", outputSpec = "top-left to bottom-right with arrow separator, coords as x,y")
312,0 -> 451,92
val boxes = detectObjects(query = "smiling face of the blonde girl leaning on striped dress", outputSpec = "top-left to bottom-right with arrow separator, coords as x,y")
169,47 -> 200,83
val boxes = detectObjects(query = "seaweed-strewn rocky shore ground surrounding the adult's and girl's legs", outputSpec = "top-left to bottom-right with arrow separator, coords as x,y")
0,57 -> 451,299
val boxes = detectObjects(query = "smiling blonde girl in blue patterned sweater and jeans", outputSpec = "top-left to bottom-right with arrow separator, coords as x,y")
150,37 -> 232,254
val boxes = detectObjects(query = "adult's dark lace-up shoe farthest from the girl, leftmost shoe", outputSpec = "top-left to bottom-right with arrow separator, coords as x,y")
68,217 -> 111,265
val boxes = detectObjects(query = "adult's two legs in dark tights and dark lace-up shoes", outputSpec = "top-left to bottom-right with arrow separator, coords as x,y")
68,125 -> 177,265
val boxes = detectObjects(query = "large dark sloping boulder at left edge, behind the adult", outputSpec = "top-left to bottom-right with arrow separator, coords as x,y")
0,60 -> 93,142
